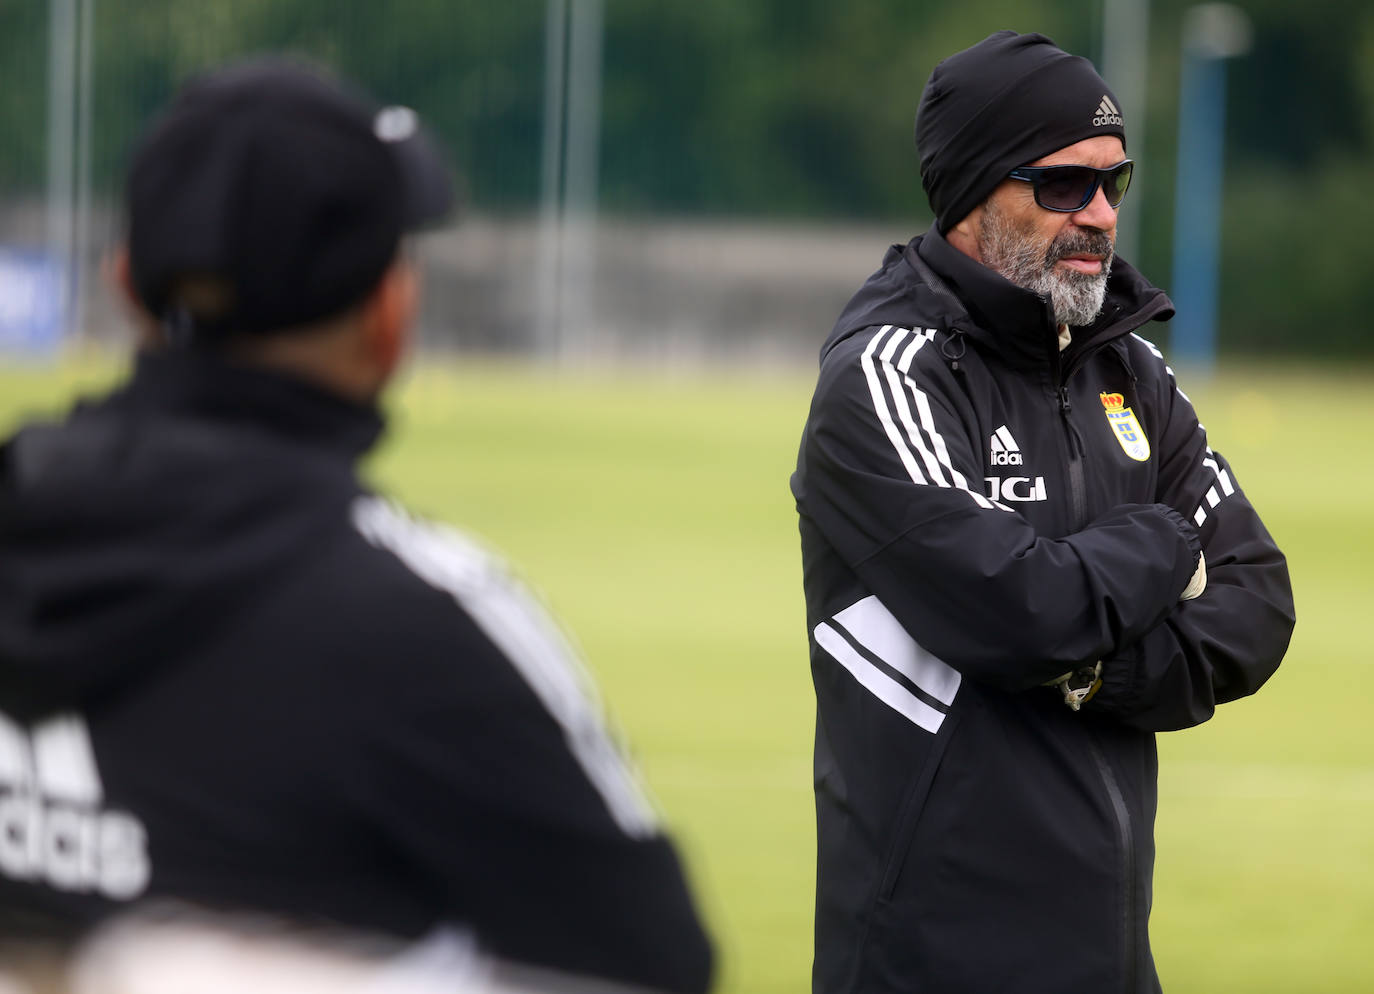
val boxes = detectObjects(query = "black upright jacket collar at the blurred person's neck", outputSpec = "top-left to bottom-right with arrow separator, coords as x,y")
109,349 -> 385,459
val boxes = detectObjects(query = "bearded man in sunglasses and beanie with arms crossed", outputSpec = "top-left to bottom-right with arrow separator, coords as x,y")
791,32 -> 1294,994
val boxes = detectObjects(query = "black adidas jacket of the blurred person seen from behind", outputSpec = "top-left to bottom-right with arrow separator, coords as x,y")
0,347 -> 710,993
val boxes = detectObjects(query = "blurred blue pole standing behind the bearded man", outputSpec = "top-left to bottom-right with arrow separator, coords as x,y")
1169,45 -> 1226,374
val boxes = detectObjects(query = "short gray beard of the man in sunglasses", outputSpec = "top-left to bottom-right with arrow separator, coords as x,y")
978,203 -> 1112,327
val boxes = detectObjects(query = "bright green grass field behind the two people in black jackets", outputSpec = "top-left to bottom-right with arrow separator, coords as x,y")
0,354 -> 1374,994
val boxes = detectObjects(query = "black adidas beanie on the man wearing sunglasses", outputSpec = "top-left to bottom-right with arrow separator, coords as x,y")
916,32 -> 1125,232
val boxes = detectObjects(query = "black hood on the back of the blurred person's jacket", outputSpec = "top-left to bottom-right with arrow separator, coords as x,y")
0,353 -> 381,718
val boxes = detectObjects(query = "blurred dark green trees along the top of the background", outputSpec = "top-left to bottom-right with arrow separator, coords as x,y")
0,0 -> 1374,353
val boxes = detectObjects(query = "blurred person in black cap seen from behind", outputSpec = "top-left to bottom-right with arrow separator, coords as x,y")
0,59 -> 712,994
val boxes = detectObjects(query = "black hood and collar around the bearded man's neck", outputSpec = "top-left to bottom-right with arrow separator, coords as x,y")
820,228 -> 1173,363
